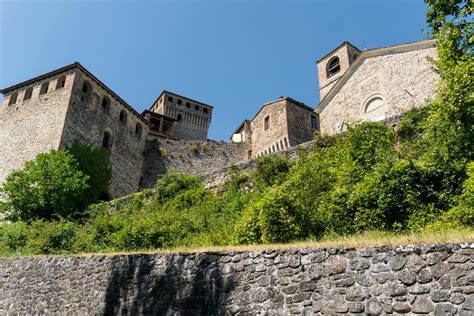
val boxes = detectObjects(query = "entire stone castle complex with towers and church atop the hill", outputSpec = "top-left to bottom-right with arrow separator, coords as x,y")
0,40 -> 439,198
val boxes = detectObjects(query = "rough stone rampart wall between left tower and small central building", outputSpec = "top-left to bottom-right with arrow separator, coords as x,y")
140,136 -> 247,188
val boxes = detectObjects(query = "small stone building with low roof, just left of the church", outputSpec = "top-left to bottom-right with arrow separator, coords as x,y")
231,97 -> 317,157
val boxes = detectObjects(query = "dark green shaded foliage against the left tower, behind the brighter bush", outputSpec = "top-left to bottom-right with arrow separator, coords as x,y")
67,141 -> 112,205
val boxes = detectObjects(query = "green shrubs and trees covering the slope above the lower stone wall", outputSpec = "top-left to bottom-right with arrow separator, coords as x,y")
0,1 -> 474,255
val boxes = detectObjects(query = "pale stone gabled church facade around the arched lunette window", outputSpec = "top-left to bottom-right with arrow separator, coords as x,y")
316,48 -> 438,134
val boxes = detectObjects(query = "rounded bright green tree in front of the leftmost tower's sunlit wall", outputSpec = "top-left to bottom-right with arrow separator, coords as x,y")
1,150 -> 90,220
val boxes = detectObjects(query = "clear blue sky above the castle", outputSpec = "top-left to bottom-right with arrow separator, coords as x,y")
0,0 -> 426,139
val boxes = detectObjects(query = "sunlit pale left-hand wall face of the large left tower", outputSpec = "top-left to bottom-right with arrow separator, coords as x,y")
0,70 -> 75,184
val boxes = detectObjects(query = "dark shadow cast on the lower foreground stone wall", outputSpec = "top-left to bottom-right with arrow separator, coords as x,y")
104,253 -> 236,315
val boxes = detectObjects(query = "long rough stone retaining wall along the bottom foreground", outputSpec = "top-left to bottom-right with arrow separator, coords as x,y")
0,243 -> 474,315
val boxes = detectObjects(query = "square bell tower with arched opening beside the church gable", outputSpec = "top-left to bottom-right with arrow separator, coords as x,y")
316,42 -> 361,100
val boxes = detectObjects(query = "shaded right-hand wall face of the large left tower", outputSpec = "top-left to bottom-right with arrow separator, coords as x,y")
61,70 -> 148,198
